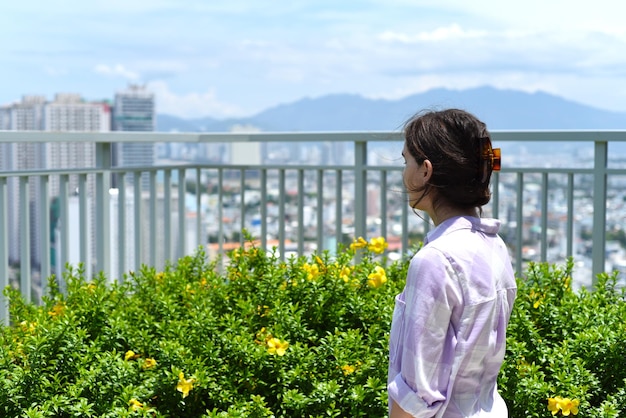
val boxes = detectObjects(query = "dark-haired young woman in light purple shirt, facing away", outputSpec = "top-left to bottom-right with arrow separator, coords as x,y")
388,109 -> 517,418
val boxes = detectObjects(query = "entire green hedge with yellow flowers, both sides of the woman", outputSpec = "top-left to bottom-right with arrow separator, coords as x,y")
0,239 -> 626,418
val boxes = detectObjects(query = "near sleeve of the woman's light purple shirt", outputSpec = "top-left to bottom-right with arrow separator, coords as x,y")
388,247 -> 462,418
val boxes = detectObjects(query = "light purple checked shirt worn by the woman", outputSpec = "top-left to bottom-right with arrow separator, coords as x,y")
387,217 -> 517,418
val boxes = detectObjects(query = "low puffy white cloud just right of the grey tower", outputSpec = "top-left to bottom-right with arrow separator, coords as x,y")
147,81 -> 242,118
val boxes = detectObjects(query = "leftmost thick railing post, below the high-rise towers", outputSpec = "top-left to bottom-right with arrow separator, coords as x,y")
95,142 -> 112,280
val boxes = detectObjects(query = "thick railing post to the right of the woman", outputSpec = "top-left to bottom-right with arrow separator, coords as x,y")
591,141 -> 608,284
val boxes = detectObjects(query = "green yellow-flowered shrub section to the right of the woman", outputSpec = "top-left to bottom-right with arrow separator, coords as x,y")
499,259 -> 626,418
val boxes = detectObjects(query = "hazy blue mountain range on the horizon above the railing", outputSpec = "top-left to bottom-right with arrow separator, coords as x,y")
157,87 -> 626,132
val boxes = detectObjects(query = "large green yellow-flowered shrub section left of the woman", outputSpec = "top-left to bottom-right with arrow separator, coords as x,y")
0,238 -> 406,417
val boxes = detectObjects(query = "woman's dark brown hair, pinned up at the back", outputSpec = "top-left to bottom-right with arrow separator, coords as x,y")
404,109 -> 491,210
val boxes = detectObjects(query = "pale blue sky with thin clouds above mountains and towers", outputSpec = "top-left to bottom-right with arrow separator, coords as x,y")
0,0 -> 626,119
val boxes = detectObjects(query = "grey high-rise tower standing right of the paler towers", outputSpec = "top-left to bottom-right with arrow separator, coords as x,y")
112,84 -> 156,190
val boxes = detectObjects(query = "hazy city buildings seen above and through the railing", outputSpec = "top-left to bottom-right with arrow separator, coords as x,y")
0,85 -> 626,298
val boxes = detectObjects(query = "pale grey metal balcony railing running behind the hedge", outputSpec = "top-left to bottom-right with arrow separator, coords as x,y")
0,131 -> 626,320
